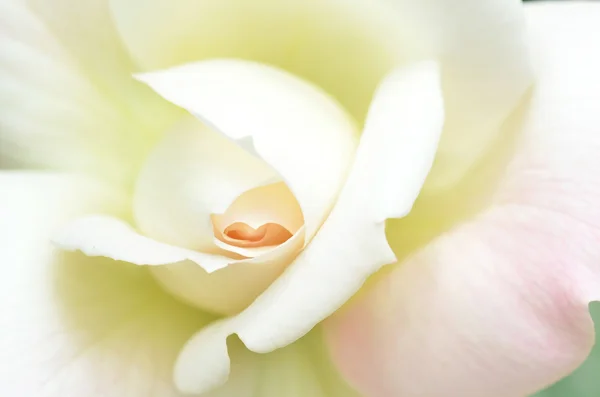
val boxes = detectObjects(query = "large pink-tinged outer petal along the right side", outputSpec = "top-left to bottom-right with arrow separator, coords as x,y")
328,3 -> 600,397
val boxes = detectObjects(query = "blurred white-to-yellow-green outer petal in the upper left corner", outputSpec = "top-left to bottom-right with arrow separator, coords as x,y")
0,0 -> 179,184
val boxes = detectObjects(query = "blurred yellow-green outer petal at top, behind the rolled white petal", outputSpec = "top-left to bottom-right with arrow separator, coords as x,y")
111,0 -> 532,187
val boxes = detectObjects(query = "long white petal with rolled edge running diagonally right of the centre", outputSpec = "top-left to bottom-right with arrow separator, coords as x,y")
175,63 -> 443,393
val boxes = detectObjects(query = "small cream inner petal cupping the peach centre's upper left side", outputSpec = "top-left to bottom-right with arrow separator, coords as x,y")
133,116 -> 280,251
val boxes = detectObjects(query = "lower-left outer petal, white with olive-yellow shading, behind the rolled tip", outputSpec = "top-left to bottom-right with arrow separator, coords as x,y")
0,172 -> 352,397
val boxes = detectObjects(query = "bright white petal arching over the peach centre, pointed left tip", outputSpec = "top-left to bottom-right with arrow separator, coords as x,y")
138,60 -> 357,240
